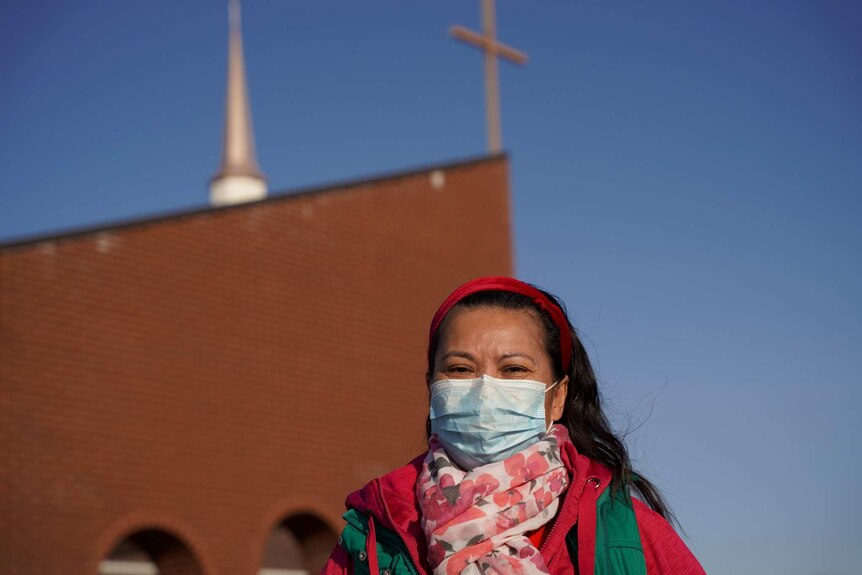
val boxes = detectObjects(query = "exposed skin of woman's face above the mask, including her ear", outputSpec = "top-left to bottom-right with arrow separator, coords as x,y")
432,306 -> 569,424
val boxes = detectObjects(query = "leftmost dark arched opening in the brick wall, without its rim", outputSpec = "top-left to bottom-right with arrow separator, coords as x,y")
99,529 -> 203,575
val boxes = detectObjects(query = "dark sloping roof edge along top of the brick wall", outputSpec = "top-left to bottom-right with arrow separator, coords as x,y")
0,152 -> 509,250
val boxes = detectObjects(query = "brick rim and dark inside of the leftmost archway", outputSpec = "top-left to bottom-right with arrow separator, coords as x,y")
95,522 -> 212,575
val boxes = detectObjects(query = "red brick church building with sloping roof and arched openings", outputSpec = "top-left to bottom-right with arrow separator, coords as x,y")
0,156 -> 512,575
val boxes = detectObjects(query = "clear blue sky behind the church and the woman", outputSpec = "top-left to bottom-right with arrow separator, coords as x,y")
0,0 -> 862,575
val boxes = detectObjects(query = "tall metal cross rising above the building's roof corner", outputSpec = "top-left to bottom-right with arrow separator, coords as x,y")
449,0 -> 527,154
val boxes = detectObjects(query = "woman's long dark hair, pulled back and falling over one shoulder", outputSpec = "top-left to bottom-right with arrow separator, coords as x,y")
426,290 -> 676,523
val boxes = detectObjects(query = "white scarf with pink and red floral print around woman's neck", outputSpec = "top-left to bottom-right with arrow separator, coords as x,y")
416,425 -> 570,575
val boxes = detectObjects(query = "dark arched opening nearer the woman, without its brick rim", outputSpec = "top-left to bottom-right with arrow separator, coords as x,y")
259,513 -> 337,575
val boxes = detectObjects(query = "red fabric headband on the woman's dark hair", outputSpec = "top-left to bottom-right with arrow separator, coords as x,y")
428,276 -> 572,372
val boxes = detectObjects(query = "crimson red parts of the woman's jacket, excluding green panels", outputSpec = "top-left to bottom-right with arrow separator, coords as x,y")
322,443 -> 705,575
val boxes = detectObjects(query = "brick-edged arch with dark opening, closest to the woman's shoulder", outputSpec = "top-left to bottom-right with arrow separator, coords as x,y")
257,508 -> 338,575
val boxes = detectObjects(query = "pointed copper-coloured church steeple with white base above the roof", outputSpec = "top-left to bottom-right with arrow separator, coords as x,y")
210,0 -> 267,206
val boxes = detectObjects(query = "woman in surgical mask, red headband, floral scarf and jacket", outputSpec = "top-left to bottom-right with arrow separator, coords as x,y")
323,277 -> 703,575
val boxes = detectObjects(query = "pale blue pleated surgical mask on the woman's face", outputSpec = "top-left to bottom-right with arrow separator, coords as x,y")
431,375 -> 559,471
